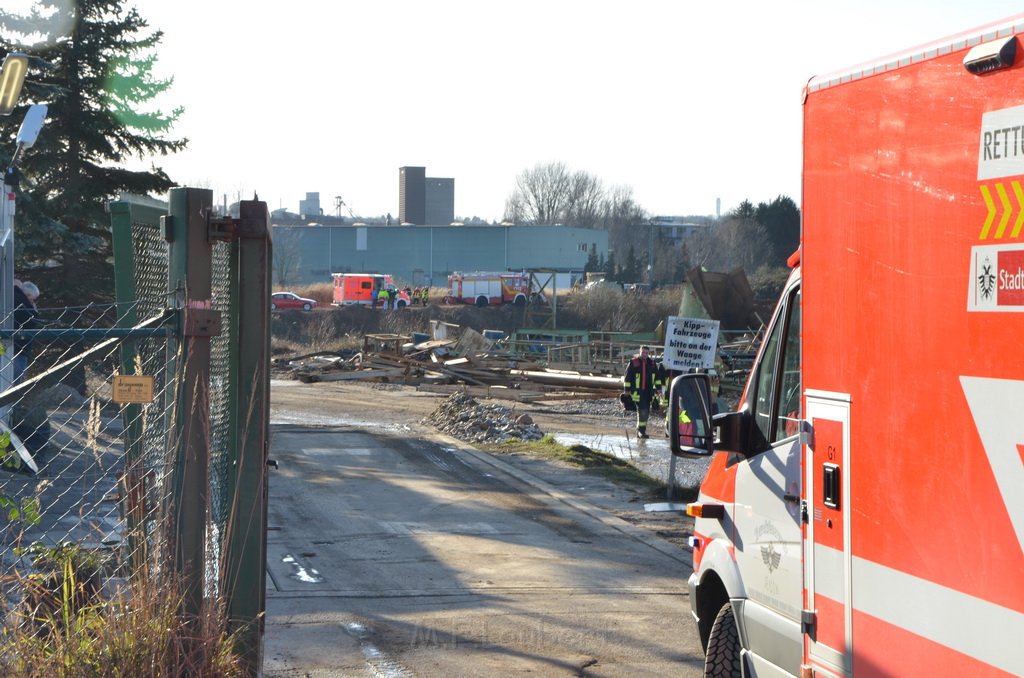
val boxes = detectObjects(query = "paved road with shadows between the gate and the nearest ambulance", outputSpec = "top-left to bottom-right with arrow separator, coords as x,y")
263,426 -> 703,678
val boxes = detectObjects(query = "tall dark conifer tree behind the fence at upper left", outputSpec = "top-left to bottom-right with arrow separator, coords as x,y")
0,0 -> 187,300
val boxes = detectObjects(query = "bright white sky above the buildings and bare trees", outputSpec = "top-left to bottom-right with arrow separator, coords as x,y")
32,0 -> 1021,219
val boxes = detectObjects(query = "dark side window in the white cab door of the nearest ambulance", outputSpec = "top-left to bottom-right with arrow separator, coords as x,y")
751,290 -> 802,452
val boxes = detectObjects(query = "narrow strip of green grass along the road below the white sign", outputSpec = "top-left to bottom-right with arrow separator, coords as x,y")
480,435 -> 667,497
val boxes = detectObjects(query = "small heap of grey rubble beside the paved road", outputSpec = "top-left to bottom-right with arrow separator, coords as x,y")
423,393 -> 544,442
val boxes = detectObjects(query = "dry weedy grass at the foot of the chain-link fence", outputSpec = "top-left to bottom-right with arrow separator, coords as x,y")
0,544 -> 248,678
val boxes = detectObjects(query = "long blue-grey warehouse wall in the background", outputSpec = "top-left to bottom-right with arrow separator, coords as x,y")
272,225 -> 608,287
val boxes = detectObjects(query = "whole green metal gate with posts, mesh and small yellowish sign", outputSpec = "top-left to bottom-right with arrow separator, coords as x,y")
0,188 -> 270,669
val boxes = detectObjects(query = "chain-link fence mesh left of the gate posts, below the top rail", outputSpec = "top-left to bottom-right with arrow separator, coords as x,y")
0,304 -> 174,589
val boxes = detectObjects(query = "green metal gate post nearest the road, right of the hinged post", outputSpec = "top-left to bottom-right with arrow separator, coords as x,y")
221,201 -> 271,676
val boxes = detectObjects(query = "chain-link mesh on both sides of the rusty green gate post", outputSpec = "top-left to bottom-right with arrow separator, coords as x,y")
0,208 -> 230,595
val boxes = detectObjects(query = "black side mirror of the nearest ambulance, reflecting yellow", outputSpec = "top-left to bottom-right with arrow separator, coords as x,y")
668,374 -> 715,457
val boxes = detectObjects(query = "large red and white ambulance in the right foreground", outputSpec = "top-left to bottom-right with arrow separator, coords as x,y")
670,15 -> 1024,678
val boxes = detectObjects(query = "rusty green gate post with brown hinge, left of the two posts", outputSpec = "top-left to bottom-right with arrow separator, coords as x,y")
165,188 -> 219,622
